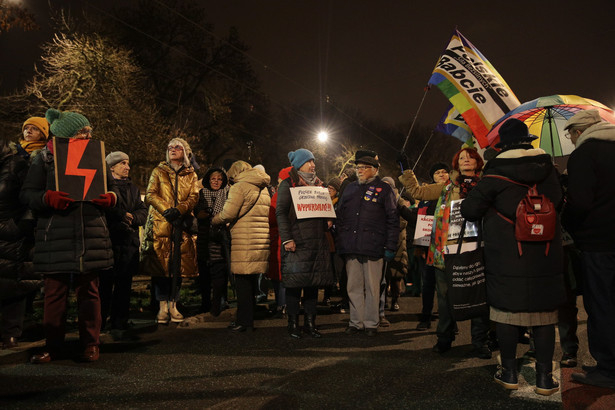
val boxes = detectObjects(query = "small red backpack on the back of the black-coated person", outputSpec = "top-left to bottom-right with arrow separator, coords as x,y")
485,175 -> 557,256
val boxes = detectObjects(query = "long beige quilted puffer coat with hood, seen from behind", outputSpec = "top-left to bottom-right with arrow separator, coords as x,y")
211,161 -> 271,275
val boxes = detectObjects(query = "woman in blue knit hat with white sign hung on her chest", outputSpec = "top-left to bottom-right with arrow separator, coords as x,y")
275,148 -> 335,338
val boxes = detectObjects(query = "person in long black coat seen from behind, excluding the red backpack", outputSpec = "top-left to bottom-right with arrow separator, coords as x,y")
461,118 -> 566,395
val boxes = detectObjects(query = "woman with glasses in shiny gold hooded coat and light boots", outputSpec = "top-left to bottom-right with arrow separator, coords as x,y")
141,138 -> 199,324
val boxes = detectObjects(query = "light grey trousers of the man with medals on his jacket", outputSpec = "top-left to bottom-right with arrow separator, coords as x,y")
346,257 -> 382,329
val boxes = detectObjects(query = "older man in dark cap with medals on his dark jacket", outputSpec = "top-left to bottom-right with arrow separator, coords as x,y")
336,151 -> 399,336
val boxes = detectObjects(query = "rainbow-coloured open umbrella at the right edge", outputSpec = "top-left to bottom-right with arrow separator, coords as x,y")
487,95 -> 615,157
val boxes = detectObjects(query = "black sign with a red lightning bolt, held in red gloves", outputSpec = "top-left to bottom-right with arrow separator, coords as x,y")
53,137 -> 107,201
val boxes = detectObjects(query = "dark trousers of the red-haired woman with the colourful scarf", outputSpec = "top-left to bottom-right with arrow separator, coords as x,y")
434,268 -> 489,347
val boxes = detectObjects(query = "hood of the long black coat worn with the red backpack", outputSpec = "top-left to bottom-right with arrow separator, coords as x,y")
484,148 -> 553,185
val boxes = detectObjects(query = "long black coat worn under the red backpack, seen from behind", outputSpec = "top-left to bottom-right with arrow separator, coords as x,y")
461,148 -> 565,312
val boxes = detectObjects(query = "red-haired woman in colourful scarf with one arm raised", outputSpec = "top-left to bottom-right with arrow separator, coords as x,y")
399,147 -> 491,359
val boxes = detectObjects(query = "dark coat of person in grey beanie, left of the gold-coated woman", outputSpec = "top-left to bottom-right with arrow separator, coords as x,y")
106,178 -> 147,266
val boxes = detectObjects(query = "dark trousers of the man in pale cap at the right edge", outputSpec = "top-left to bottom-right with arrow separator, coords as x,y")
582,251 -> 615,378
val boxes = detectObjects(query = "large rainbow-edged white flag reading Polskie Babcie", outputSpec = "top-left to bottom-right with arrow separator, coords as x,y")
429,30 -> 521,148
